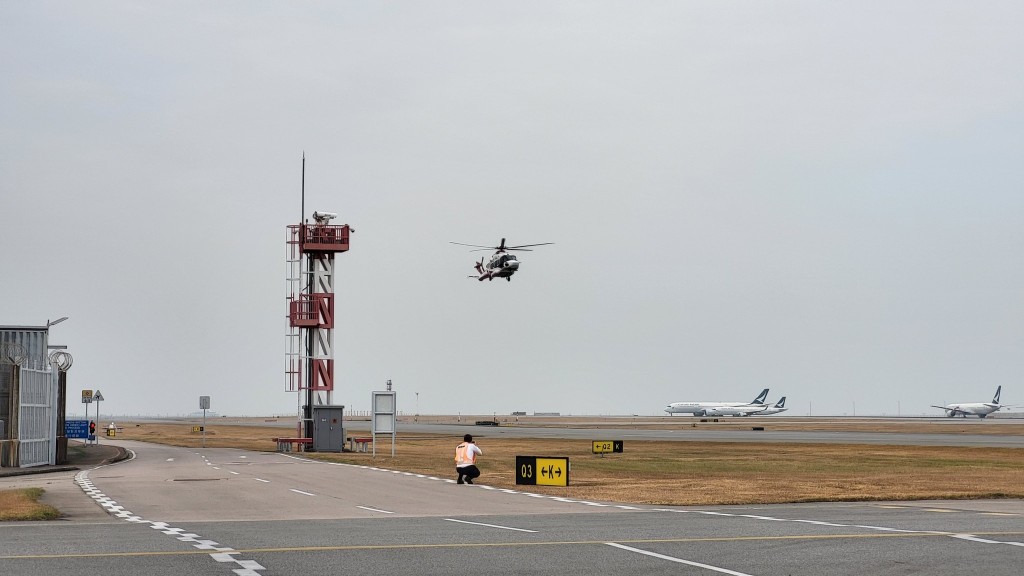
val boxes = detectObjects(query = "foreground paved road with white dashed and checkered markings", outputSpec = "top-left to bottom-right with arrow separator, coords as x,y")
0,442 -> 1024,576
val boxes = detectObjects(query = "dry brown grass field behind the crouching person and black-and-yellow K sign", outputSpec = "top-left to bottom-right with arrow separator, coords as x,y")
119,423 -> 1024,505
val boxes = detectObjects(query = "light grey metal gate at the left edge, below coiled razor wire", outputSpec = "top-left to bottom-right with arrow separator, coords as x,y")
18,367 -> 57,467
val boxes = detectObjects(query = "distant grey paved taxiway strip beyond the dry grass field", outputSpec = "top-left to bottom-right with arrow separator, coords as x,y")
360,421 -> 1024,448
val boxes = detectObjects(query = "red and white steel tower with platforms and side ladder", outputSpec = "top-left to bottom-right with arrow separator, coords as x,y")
285,212 -> 351,438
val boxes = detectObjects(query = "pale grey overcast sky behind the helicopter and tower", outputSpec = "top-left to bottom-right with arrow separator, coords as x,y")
0,0 -> 1024,415
